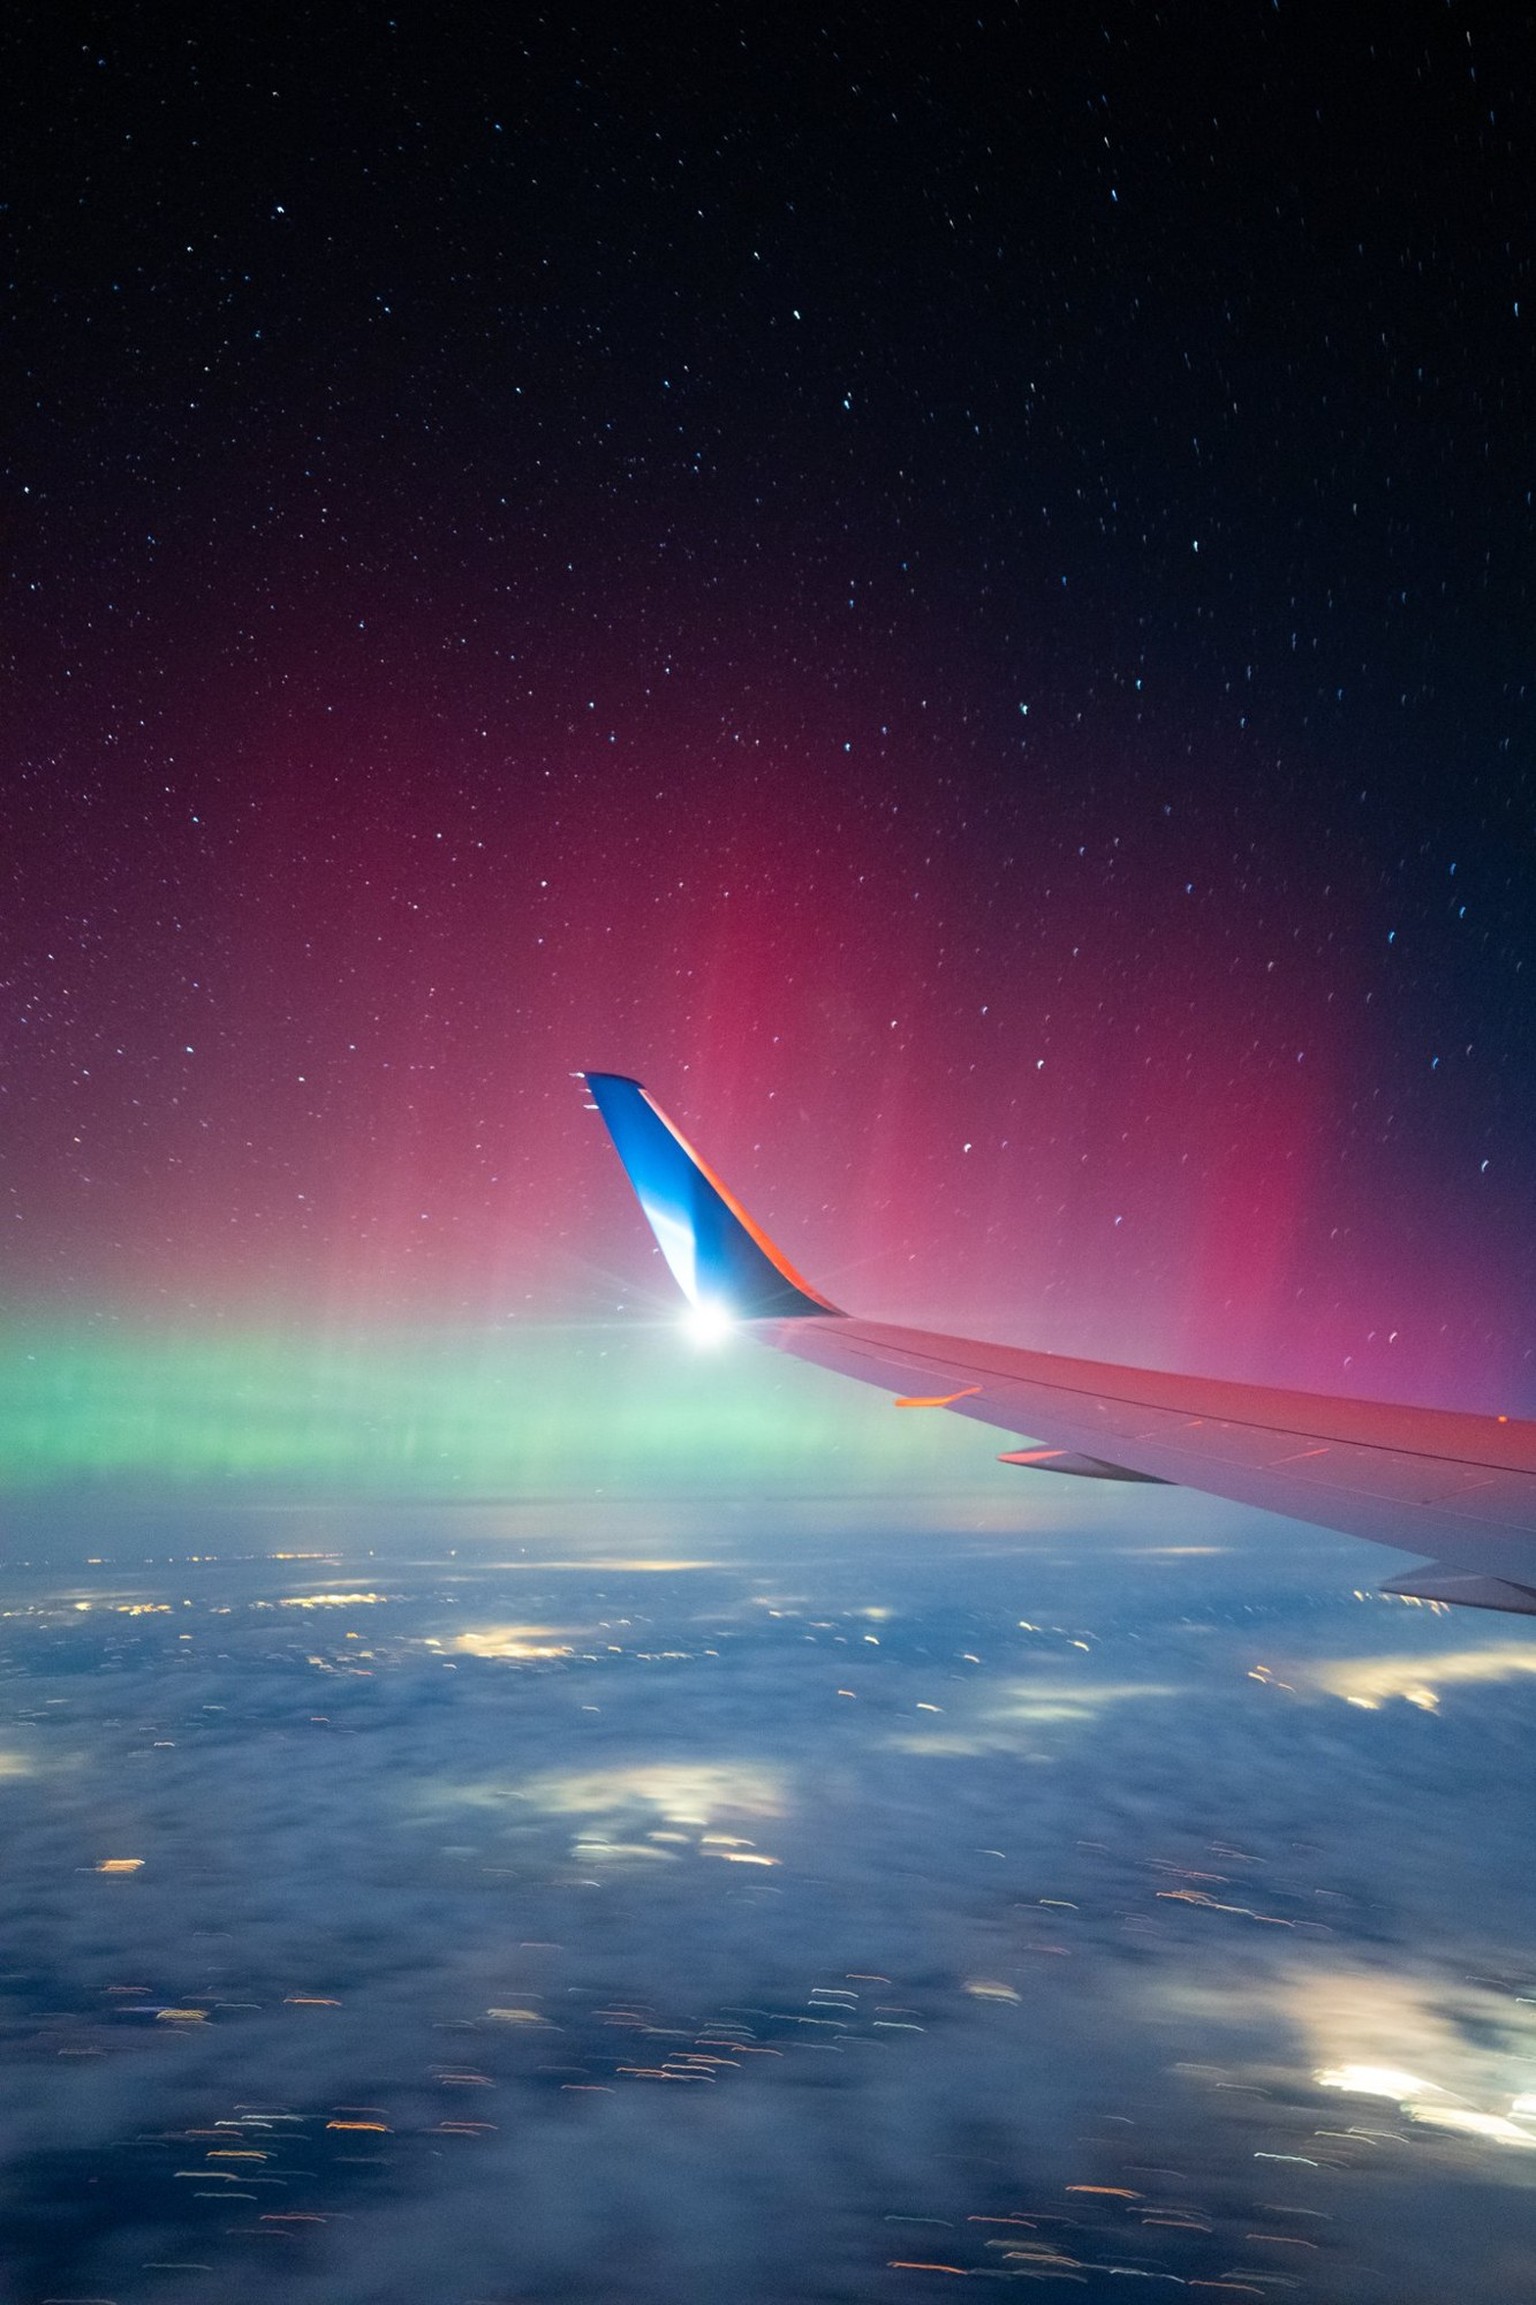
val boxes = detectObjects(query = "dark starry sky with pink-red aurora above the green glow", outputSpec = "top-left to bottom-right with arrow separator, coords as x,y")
0,0 -> 1536,1413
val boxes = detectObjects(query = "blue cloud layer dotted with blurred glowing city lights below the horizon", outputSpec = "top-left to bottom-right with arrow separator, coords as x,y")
0,1507 -> 1536,2305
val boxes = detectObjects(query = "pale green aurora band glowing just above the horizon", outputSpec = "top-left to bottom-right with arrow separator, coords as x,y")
0,1318 -> 991,1501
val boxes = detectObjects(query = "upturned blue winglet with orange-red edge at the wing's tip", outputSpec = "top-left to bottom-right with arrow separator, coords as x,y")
583,1072 -> 839,1321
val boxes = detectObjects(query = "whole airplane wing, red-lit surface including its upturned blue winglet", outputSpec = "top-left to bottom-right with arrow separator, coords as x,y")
583,1072 -> 1536,1616
